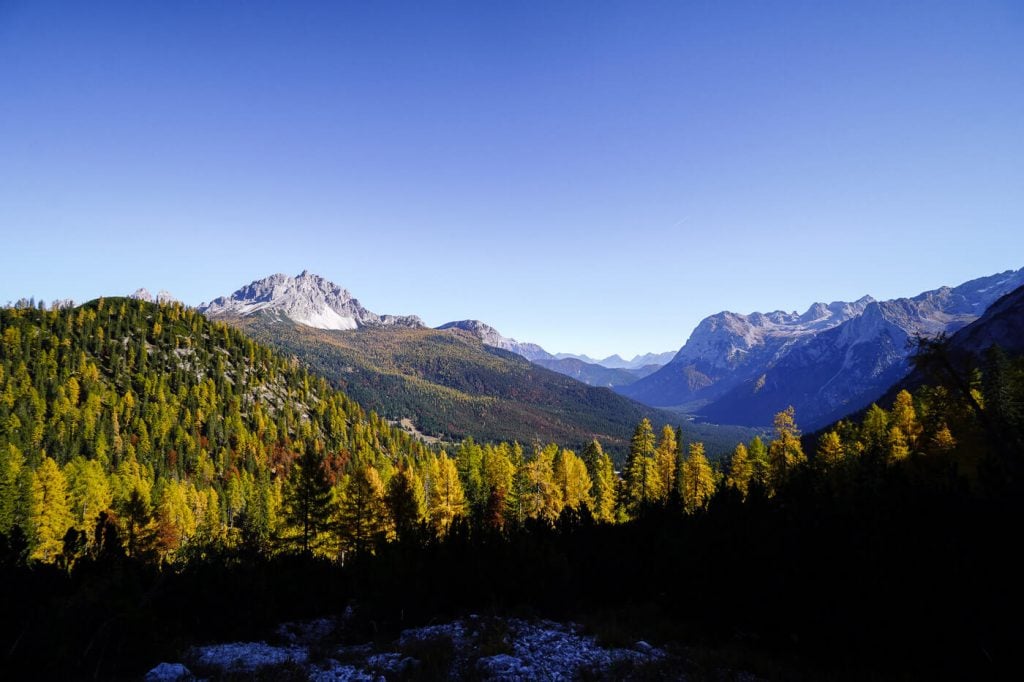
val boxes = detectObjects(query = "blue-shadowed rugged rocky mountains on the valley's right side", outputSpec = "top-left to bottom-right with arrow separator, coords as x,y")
617,268 -> 1024,428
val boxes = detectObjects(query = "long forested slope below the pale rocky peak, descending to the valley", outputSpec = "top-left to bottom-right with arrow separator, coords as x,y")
225,314 -> 678,453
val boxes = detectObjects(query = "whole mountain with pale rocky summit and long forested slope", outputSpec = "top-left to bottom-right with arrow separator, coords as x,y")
200,272 -> 700,453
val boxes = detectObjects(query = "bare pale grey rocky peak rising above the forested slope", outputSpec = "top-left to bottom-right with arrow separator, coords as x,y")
199,270 -> 424,330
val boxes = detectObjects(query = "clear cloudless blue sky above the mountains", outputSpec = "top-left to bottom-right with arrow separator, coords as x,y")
0,0 -> 1024,356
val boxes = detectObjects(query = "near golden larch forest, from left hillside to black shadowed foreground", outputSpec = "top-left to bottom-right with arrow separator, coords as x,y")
0,299 -> 1024,679
